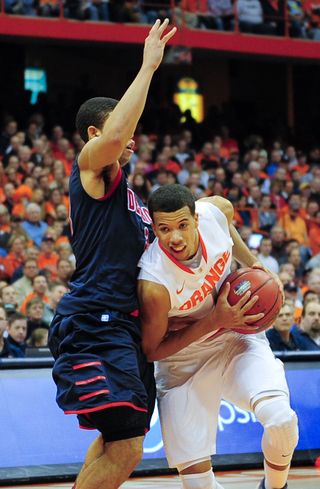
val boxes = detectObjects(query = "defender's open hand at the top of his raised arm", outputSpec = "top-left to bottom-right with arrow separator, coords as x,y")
143,19 -> 177,71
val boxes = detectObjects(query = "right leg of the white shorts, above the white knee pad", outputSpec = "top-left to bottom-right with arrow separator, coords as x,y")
222,333 -> 288,411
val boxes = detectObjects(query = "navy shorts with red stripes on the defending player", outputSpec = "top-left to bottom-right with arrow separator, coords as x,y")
52,314 -> 154,427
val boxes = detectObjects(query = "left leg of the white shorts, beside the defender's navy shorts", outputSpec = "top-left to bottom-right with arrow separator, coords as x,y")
156,340 -> 222,467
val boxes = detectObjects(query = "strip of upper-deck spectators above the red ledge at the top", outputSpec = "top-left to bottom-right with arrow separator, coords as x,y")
4,0 -> 320,40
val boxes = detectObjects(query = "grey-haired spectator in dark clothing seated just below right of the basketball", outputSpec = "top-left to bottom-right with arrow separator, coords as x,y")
266,302 -> 304,351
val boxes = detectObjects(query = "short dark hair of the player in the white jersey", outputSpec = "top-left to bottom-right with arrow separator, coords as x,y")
148,184 -> 196,219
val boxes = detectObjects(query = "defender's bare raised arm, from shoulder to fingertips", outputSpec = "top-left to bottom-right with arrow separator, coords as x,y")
79,19 -> 176,171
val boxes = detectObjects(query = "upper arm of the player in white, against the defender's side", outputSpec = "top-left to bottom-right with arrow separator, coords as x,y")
138,280 -> 171,357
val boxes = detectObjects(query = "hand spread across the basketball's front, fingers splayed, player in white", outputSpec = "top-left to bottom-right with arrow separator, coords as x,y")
212,282 -> 264,332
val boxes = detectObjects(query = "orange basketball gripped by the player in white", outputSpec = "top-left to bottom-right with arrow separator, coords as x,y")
218,268 -> 282,334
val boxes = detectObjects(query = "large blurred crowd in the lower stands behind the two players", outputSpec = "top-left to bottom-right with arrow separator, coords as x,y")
0,101 -> 320,358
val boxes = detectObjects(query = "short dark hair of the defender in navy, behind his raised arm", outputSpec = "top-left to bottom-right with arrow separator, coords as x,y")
76,97 -> 118,143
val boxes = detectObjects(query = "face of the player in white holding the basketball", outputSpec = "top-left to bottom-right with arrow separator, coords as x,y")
153,206 -> 199,261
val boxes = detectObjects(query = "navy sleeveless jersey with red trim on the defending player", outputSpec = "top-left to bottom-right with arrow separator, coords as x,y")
57,159 -> 154,316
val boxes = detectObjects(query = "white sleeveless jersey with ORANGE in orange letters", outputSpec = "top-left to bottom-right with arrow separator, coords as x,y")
138,202 -> 233,318
